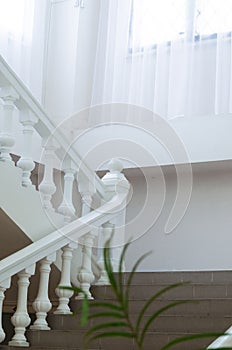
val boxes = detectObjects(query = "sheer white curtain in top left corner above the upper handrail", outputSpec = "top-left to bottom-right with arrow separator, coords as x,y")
0,0 -> 48,99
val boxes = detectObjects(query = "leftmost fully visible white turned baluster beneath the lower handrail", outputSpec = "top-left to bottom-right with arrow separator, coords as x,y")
8,265 -> 35,347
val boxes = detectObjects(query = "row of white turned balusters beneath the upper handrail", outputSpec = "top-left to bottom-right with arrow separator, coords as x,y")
0,87 -> 79,221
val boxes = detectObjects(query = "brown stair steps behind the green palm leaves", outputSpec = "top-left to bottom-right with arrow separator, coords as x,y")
0,271 -> 232,350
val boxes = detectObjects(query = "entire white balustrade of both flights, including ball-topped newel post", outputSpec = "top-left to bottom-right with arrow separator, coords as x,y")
0,56 -> 129,347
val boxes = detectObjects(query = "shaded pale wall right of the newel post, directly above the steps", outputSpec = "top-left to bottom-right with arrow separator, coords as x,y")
126,161 -> 232,271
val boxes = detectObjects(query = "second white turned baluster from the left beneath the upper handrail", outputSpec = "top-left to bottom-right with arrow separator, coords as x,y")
17,110 -> 38,186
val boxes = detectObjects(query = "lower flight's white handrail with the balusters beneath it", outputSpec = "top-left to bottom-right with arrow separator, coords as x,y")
0,185 -> 128,347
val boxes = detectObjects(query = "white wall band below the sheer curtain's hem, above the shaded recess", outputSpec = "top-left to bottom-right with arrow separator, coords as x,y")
64,108 -> 232,169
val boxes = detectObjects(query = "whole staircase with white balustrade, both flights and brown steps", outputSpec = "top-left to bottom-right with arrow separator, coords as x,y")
0,57 -> 232,350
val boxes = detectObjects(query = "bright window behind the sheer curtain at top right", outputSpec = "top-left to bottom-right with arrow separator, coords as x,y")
130,0 -> 232,49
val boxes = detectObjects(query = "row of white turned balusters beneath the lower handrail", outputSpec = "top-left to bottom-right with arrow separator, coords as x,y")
0,222 -> 116,347
